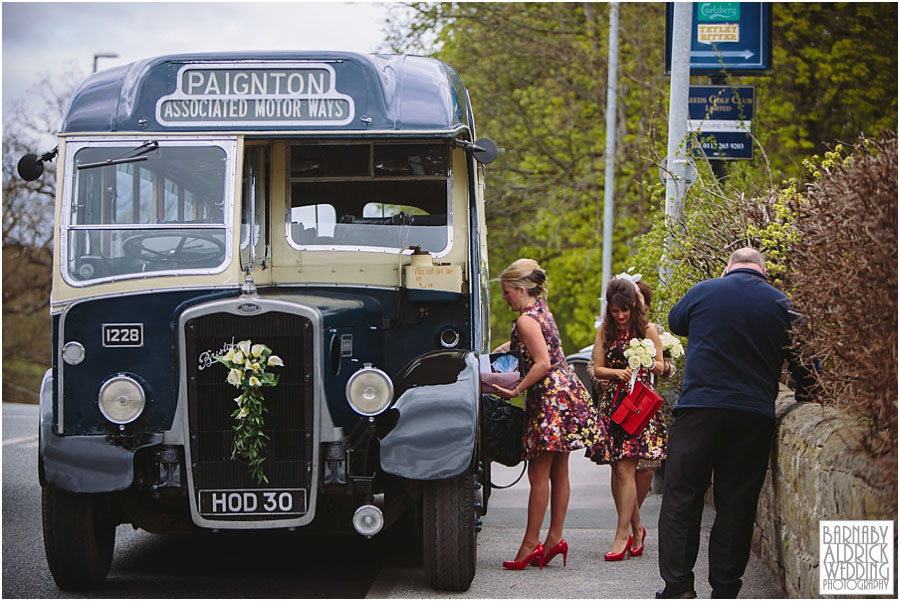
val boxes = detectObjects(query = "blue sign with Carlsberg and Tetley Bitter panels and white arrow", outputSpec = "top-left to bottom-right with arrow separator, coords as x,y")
666,2 -> 772,75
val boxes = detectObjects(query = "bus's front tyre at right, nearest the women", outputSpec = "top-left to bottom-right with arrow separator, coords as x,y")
422,475 -> 476,591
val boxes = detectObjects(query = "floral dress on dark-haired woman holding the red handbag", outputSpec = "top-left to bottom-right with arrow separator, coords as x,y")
589,329 -> 668,464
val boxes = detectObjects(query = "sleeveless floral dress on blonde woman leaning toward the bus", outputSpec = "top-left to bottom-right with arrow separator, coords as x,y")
510,298 -> 607,459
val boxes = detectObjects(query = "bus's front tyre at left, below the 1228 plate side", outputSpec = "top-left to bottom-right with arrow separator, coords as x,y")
41,486 -> 116,590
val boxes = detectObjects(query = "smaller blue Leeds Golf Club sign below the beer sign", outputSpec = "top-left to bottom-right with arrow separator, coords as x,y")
688,86 -> 755,159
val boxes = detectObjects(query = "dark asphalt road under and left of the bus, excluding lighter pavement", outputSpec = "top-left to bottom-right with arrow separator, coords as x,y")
2,403 -> 384,599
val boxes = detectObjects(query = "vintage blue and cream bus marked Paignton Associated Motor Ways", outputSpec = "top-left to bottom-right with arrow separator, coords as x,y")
20,52 -> 496,590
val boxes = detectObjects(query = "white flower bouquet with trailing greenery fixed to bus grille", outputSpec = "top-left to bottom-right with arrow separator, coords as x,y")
215,340 -> 284,484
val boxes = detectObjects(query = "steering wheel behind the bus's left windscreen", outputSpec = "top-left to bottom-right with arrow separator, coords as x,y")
122,231 -> 225,265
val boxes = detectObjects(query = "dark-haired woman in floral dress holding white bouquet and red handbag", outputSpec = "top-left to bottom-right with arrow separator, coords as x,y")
591,278 -> 666,561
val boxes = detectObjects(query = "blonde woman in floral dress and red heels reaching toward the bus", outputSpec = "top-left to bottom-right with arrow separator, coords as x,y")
494,259 -> 606,570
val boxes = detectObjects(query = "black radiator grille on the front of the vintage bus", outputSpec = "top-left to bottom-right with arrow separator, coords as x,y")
185,312 -> 315,520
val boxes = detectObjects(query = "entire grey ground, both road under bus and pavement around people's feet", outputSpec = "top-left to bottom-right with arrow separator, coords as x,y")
2,403 -> 783,599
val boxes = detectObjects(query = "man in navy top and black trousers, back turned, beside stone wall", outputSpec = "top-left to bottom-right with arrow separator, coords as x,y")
656,248 -> 814,598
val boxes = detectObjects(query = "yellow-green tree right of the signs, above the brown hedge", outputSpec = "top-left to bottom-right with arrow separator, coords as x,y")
749,2 -> 897,173
